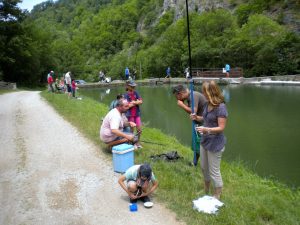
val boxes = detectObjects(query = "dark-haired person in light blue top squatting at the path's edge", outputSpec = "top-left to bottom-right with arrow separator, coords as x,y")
119,163 -> 158,203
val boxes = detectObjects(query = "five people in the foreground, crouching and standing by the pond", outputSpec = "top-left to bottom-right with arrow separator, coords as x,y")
100,78 -> 228,205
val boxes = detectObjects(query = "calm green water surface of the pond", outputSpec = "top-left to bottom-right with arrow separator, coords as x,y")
80,85 -> 300,187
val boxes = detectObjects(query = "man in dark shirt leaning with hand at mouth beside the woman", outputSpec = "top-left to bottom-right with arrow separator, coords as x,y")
173,85 -> 206,166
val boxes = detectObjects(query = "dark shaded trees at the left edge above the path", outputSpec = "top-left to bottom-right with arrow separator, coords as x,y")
0,0 -> 53,85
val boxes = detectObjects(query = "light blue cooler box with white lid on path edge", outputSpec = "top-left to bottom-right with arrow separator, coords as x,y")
112,144 -> 134,173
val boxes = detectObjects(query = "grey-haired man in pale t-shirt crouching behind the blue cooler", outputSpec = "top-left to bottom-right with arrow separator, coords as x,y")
100,99 -> 136,147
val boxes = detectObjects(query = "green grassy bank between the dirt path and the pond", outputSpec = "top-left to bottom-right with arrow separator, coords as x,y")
42,91 -> 300,225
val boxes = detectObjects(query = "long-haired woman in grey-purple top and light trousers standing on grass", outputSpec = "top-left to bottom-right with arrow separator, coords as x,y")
196,81 -> 228,199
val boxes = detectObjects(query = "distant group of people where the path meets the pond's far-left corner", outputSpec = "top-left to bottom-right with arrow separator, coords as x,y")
47,70 -> 77,98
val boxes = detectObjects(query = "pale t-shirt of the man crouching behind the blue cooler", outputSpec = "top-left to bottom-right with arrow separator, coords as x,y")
100,108 -> 124,143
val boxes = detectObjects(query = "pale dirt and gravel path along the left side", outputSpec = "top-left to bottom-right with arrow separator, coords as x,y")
0,91 -> 184,225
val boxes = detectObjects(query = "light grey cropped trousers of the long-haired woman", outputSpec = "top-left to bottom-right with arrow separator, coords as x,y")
200,145 -> 225,188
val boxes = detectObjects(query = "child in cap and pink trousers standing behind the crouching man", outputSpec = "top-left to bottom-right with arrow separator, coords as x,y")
124,81 -> 143,148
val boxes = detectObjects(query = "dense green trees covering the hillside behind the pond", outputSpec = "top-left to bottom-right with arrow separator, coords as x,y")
0,0 -> 300,83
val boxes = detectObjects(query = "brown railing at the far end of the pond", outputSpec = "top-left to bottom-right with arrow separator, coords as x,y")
192,67 -> 243,77
